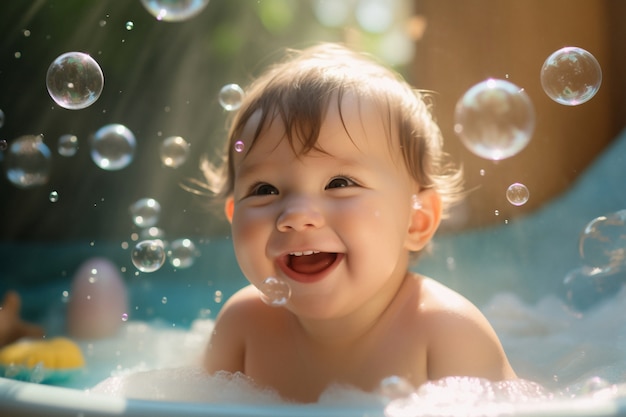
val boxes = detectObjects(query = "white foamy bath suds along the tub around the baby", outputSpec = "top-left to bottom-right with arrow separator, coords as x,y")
83,290 -> 626,406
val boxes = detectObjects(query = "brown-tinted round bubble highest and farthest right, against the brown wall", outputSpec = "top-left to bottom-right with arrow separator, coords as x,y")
540,47 -> 602,106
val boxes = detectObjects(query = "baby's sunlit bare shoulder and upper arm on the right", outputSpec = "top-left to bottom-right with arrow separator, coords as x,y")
426,284 -> 516,381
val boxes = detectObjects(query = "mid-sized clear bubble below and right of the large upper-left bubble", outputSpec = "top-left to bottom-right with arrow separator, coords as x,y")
91,124 -> 136,171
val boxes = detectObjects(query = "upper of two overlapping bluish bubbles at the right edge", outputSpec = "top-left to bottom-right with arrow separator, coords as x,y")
578,210 -> 626,269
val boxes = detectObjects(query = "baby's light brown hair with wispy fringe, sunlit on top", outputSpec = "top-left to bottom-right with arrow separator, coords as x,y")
202,43 -> 462,215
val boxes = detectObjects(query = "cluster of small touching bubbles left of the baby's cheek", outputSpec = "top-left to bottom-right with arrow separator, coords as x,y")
129,198 -> 198,273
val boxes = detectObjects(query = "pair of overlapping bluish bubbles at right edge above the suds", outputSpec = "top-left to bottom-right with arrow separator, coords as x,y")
563,210 -> 626,309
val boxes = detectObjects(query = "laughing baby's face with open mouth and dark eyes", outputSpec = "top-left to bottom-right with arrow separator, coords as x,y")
226,97 -> 417,318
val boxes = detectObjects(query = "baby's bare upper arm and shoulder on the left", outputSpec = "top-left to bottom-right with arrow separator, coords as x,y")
204,287 -> 258,374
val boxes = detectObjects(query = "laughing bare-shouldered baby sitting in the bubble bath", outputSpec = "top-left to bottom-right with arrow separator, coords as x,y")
204,44 -> 515,402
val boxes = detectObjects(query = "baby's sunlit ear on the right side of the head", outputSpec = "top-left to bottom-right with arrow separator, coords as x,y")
405,189 -> 441,252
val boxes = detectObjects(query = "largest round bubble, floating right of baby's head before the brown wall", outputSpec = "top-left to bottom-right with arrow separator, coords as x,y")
454,79 -> 535,161
